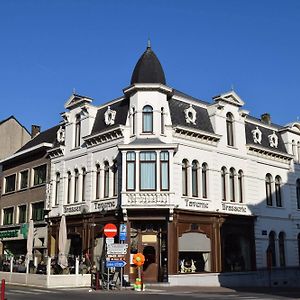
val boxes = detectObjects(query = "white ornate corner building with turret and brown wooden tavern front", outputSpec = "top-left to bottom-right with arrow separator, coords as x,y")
46,46 -> 300,282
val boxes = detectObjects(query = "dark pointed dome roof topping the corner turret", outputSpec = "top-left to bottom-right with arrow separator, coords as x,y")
131,46 -> 166,84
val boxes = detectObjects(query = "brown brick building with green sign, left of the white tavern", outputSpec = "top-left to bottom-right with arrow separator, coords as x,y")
0,126 -> 58,259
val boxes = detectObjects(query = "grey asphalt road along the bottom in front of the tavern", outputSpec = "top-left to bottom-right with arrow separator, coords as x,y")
5,286 -> 300,300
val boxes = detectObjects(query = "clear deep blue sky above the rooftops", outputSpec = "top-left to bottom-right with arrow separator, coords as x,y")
0,0 -> 300,130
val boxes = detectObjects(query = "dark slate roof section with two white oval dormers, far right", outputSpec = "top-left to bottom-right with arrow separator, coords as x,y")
245,117 -> 287,153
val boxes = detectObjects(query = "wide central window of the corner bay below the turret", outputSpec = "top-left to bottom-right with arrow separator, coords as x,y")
140,152 -> 156,191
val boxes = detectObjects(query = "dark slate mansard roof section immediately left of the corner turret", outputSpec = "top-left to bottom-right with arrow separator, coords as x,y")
91,98 -> 129,135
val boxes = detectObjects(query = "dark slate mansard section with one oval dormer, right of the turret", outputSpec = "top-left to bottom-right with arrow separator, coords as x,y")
169,99 -> 214,133
